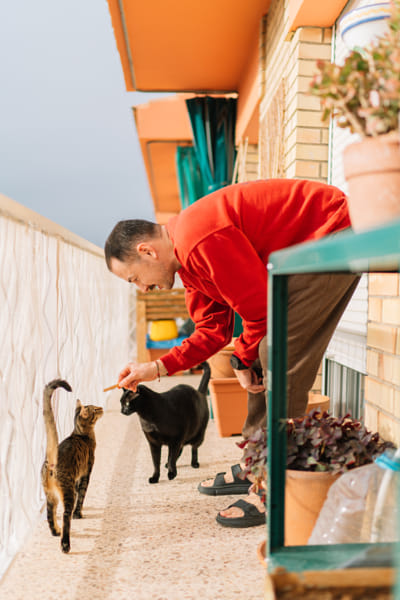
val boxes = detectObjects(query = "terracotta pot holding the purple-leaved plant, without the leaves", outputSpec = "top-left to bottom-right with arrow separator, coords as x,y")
285,469 -> 339,546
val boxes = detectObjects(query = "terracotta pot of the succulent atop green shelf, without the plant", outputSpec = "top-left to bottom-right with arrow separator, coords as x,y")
343,133 -> 400,232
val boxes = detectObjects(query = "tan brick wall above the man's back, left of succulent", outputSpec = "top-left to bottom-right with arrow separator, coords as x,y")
260,0 -> 332,181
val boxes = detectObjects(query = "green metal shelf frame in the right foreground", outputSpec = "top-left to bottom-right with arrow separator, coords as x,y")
266,221 -> 400,571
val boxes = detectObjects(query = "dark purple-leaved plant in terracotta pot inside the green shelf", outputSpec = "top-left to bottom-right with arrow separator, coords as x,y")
238,409 -> 393,546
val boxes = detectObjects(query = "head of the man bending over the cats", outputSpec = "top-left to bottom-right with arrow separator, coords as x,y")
104,219 -> 179,292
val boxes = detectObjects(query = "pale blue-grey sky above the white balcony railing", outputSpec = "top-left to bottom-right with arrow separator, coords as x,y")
0,0 -> 170,247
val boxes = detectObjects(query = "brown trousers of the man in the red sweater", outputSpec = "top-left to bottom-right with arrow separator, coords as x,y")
242,273 -> 360,438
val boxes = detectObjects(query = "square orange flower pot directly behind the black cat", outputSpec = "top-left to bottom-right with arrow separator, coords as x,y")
209,377 -> 247,437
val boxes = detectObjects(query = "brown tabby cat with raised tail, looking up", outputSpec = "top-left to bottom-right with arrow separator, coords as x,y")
42,379 -> 103,552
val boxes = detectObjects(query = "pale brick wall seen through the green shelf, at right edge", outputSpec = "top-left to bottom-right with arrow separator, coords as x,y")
365,273 -> 400,445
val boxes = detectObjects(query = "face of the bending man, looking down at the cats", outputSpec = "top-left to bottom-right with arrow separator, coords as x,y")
110,255 -> 175,292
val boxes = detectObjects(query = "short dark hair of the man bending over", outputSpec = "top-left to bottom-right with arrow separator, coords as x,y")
104,219 -> 160,270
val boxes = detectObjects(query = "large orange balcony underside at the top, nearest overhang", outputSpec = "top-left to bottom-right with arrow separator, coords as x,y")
108,0 -> 270,93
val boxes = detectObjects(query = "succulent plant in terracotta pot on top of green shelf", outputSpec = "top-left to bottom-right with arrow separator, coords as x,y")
310,0 -> 400,231
